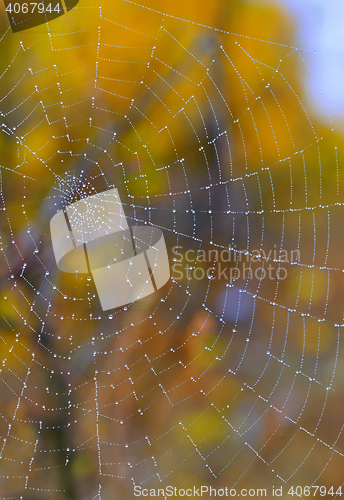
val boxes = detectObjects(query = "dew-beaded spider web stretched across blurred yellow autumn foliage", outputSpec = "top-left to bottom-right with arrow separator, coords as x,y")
0,0 -> 344,500
